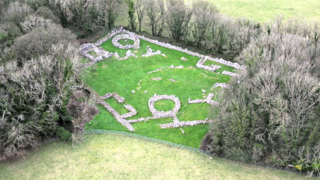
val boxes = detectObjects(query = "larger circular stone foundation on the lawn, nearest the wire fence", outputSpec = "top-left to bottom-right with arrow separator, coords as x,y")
148,95 -> 181,118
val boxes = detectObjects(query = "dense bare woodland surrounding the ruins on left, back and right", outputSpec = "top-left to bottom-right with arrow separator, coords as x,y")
0,0 -> 320,176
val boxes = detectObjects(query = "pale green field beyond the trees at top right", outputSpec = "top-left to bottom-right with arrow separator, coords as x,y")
186,0 -> 320,22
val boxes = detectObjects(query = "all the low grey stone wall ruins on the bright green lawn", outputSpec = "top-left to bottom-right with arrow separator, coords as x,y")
80,28 -> 245,131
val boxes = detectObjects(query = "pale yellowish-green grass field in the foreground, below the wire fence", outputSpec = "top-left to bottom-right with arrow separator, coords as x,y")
0,134 -> 313,180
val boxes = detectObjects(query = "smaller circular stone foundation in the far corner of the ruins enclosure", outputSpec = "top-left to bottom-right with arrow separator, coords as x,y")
112,34 -> 140,49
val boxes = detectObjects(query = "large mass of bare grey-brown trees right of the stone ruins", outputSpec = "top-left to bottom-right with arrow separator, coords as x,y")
210,33 -> 320,176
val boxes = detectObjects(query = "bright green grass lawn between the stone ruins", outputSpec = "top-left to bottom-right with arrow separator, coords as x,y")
82,37 -> 235,148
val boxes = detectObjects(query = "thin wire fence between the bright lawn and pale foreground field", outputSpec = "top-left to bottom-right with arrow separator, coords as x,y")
85,129 -> 210,155
